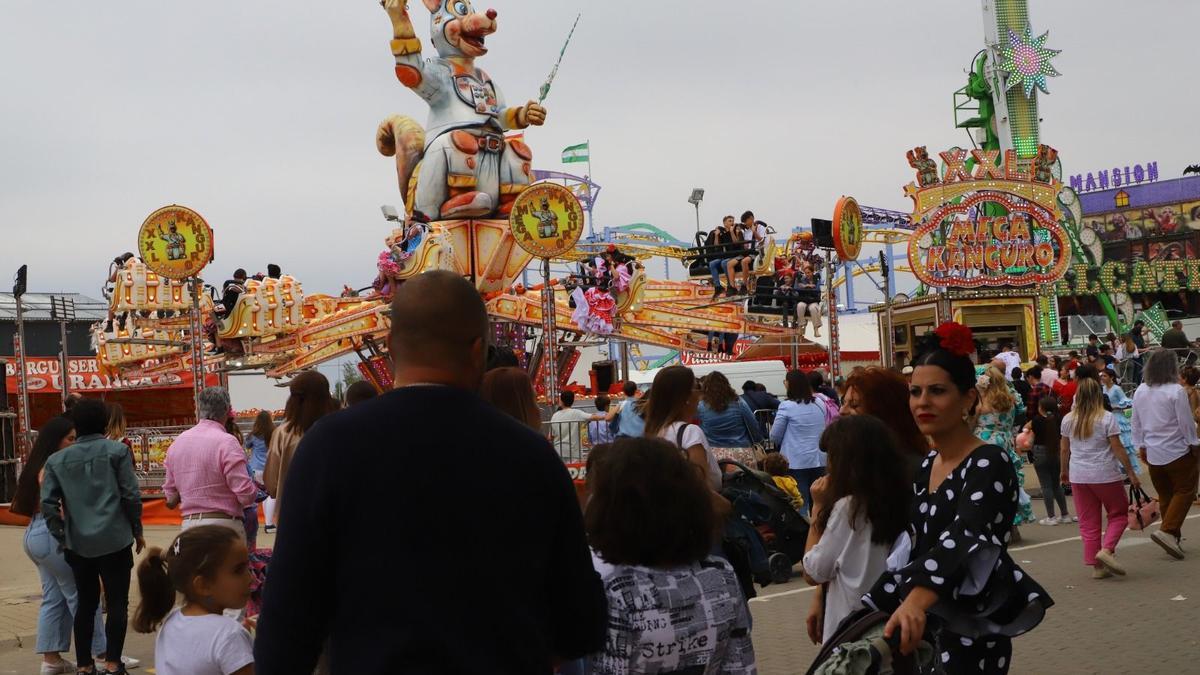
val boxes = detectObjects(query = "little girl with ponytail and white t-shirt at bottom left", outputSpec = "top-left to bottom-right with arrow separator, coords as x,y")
133,525 -> 254,675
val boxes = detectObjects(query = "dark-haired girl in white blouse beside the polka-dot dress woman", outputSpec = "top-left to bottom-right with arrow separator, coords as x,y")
804,414 -> 912,644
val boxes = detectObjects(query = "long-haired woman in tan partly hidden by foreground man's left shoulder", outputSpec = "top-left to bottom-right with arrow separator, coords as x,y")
263,370 -> 338,526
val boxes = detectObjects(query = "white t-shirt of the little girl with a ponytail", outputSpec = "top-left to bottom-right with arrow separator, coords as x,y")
154,608 -> 254,675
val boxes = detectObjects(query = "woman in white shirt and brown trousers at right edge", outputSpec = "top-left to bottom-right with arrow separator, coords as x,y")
1133,350 -> 1200,558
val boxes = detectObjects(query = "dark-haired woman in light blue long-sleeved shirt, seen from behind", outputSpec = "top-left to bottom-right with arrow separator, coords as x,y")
770,370 -> 826,513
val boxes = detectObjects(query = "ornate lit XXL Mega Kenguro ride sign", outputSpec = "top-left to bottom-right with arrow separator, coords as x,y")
905,145 -> 1070,288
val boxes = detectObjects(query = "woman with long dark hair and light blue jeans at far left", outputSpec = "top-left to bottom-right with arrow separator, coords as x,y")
8,417 -> 104,675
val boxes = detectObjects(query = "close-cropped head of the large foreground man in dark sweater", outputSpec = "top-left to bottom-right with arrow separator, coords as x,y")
390,270 -> 487,387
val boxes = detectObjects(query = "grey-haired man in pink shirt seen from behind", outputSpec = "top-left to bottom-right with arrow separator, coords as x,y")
162,387 -> 257,537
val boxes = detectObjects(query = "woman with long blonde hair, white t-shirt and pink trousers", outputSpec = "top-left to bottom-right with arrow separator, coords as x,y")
1061,377 -> 1141,579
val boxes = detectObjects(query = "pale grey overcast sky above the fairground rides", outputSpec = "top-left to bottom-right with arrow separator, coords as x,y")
0,0 -> 1200,295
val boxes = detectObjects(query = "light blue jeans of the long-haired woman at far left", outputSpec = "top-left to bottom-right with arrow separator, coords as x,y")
25,514 -> 104,656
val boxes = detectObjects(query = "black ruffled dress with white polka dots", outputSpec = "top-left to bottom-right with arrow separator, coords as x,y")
863,444 -> 1054,675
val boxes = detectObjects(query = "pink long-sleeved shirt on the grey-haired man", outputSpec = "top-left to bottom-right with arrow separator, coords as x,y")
162,419 -> 257,518
